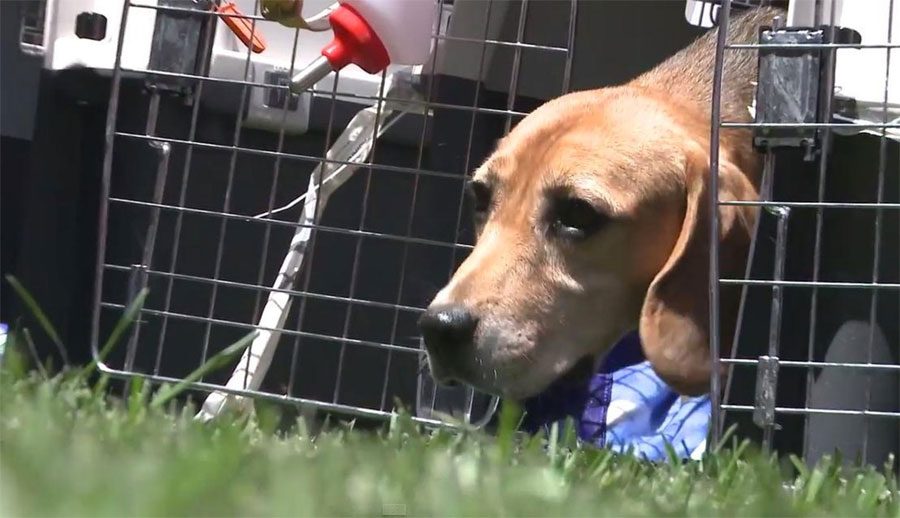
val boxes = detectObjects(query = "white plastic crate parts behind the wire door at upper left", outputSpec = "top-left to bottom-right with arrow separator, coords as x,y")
28,0 -> 449,133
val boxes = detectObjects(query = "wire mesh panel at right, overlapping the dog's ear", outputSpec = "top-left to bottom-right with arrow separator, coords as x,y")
710,0 -> 900,470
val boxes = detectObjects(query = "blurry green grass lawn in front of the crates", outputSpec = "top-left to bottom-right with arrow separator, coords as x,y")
0,280 -> 900,517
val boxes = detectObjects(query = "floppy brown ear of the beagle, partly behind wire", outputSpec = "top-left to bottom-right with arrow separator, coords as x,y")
640,153 -> 757,395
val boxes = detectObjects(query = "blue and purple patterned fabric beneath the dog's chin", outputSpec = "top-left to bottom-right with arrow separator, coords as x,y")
523,332 -> 711,461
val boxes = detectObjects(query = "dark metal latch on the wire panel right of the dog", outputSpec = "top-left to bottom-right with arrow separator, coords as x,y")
753,20 -> 861,160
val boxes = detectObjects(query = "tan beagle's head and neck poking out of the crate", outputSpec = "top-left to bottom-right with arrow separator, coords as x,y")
419,8 -> 783,400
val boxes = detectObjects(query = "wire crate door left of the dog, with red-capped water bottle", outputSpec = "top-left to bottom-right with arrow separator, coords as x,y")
93,0 -> 576,428
